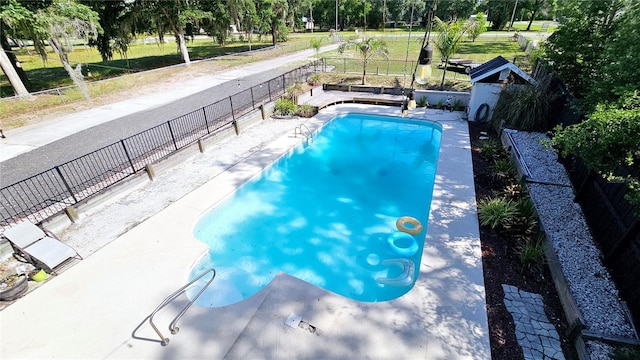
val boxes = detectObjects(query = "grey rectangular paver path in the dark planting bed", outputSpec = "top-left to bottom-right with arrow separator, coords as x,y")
502,284 -> 564,360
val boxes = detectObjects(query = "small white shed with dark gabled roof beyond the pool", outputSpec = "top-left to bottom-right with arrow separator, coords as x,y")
467,56 -> 536,121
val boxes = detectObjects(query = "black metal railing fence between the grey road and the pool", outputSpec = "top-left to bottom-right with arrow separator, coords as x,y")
0,60 -> 323,229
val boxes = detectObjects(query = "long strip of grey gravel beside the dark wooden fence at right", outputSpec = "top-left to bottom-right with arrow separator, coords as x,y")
509,131 -> 635,359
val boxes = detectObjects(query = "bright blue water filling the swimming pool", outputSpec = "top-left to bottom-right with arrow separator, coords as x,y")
191,114 -> 441,307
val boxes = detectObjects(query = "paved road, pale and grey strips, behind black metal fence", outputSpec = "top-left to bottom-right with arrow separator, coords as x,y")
0,44 -> 338,188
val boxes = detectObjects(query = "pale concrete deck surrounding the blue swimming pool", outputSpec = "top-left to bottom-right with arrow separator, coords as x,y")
0,104 -> 491,359
